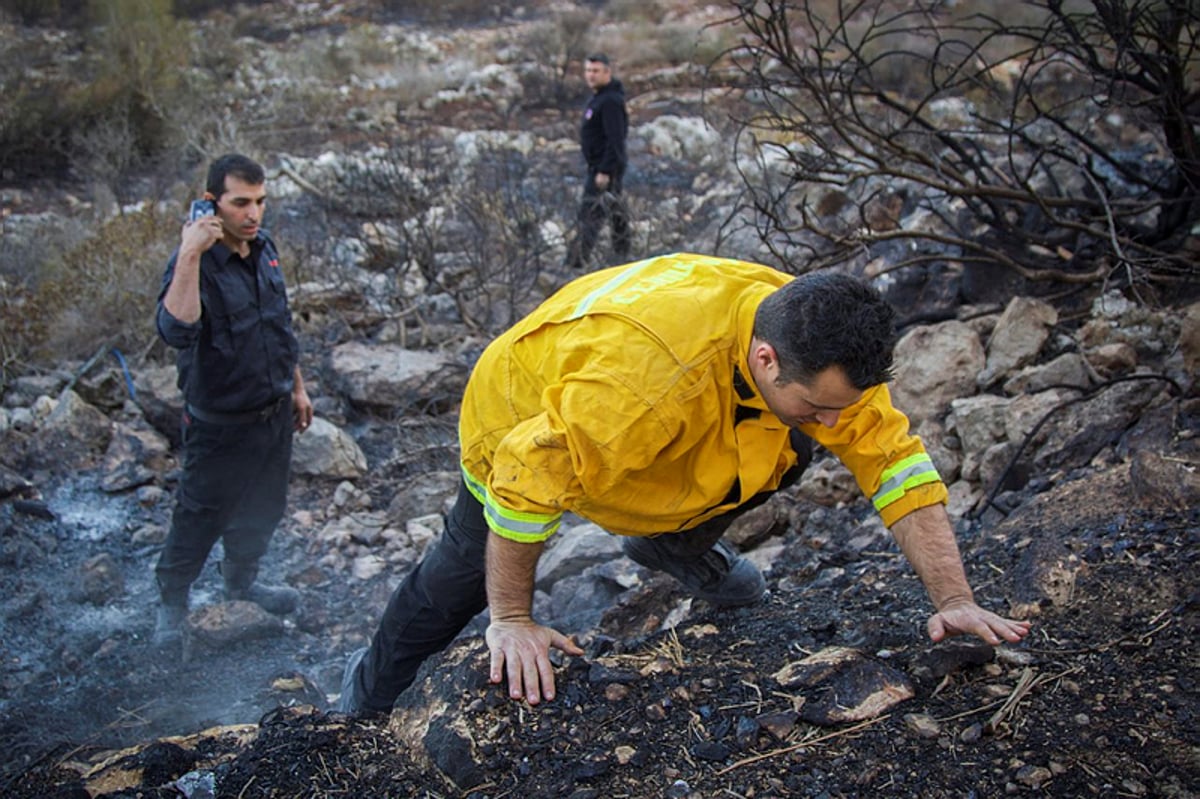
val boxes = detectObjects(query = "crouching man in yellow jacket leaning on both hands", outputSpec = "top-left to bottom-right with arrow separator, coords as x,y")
338,254 -> 1028,714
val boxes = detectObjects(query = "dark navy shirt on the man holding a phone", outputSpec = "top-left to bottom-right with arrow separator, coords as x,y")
156,233 -> 300,413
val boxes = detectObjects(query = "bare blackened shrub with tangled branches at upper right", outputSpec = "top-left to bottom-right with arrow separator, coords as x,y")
727,0 -> 1200,283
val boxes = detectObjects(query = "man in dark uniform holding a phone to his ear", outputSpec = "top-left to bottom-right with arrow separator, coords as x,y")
154,154 -> 312,645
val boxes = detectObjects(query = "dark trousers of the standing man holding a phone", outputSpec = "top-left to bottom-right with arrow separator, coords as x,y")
155,398 -> 292,603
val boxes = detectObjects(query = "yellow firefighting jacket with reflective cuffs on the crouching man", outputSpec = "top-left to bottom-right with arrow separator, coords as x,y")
458,254 -> 947,542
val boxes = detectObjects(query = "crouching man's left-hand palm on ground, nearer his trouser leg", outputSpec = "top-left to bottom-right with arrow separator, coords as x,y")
487,619 -> 583,704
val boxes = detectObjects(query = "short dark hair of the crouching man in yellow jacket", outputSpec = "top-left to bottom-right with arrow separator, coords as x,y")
754,272 -> 896,391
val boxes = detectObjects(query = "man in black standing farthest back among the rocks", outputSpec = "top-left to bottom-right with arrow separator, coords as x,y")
568,53 -> 630,270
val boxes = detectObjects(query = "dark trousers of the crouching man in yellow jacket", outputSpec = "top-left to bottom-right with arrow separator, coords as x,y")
352,434 -> 812,713
